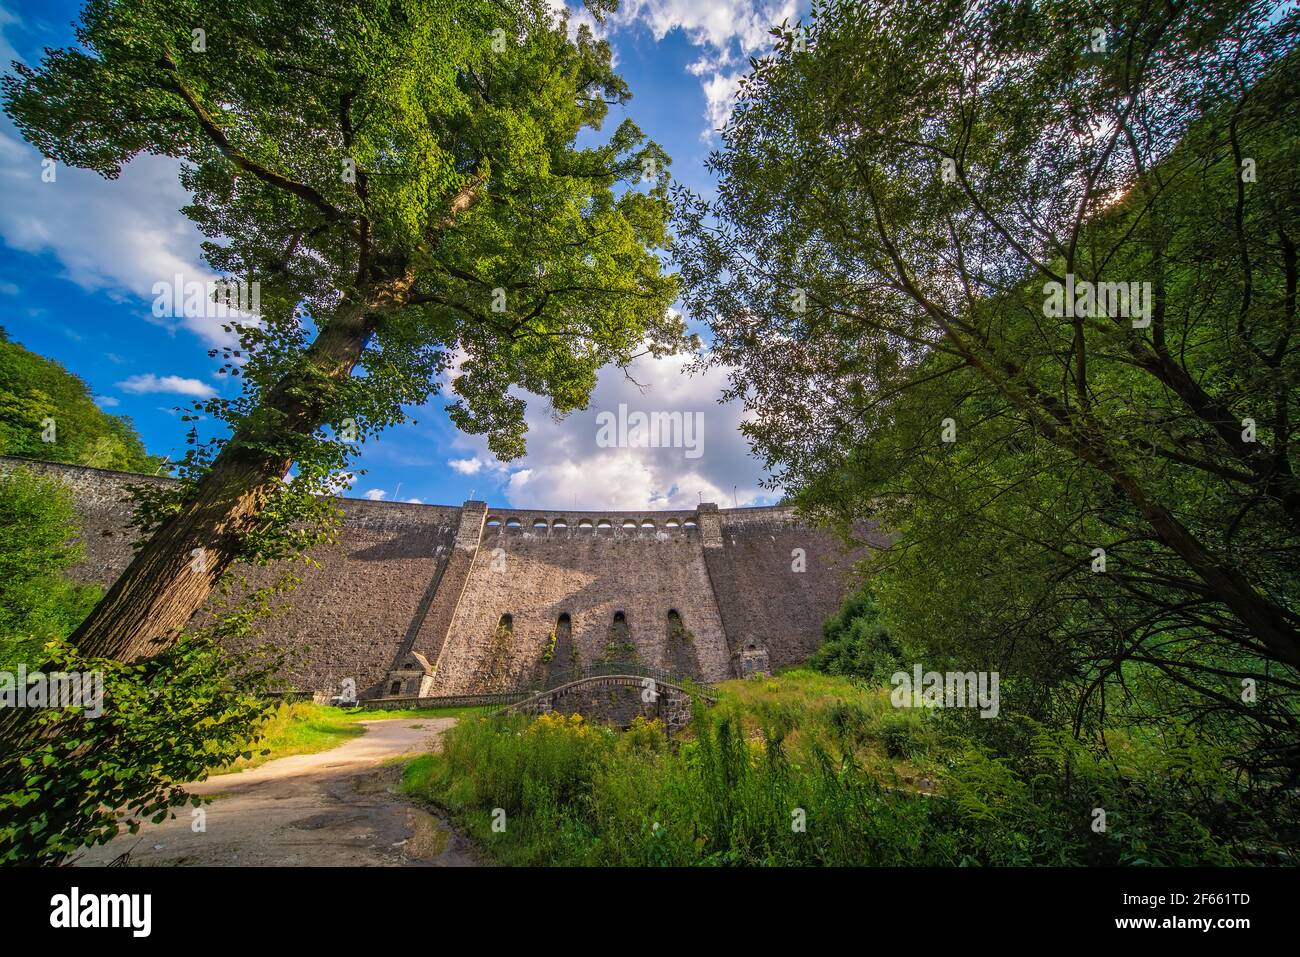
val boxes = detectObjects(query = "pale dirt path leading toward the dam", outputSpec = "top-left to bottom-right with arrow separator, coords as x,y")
77,718 -> 477,867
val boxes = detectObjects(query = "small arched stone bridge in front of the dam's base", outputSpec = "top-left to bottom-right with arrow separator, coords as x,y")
501,674 -> 718,735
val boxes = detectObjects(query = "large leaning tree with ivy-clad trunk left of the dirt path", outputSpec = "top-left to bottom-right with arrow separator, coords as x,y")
4,0 -> 688,661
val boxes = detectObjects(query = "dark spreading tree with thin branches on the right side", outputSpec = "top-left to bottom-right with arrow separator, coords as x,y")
675,0 -> 1300,754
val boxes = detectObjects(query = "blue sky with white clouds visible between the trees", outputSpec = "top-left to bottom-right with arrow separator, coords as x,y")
0,0 -> 806,508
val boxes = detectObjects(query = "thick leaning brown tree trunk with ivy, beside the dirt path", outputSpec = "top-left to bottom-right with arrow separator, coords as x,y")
70,299 -> 378,661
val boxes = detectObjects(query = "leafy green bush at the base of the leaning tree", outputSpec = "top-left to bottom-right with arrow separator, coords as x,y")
0,636 -> 274,865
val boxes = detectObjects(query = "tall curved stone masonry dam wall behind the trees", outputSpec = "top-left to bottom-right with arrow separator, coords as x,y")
0,456 -> 873,696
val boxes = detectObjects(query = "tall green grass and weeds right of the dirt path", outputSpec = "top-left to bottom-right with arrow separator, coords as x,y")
403,671 -> 1231,866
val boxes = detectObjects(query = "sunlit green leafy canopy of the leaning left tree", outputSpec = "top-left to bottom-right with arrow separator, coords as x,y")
4,0 -> 677,456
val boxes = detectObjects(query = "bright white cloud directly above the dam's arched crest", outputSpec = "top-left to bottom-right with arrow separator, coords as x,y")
458,343 -> 775,511
